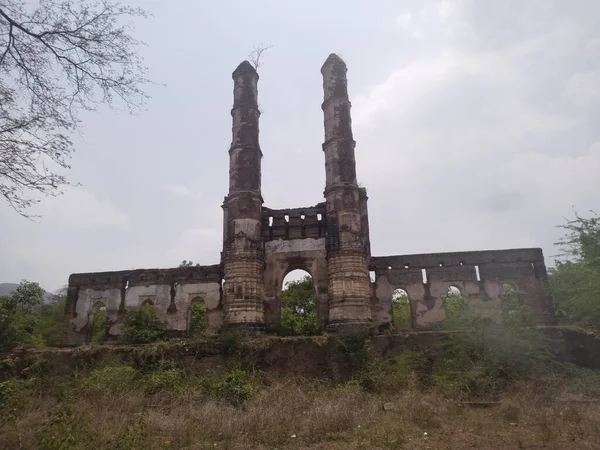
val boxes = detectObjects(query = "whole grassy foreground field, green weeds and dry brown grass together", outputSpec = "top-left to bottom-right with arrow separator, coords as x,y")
0,352 -> 600,450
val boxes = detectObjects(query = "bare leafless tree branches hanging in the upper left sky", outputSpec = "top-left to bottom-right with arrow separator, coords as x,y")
0,0 -> 149,217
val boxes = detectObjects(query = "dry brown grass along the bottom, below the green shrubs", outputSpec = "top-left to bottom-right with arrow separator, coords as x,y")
0,370 -> 600,449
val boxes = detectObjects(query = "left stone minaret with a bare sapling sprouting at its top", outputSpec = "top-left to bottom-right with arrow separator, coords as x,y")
221,61 -> 264,331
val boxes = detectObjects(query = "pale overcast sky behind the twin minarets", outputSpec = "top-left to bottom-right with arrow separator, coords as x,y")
0,0 -> 600,290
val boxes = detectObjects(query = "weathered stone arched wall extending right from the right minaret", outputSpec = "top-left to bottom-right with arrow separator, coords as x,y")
370,248 -> 555,328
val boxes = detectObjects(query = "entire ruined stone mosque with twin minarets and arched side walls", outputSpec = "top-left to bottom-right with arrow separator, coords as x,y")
65,54 -> 553,343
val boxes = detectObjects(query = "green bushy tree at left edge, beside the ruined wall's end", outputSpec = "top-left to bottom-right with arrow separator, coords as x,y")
0,280 -> 44,353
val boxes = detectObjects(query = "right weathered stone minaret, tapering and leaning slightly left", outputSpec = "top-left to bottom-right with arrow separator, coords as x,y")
321,54 -> 371,331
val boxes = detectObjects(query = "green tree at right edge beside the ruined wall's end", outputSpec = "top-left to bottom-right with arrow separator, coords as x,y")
549,211 -> 600,330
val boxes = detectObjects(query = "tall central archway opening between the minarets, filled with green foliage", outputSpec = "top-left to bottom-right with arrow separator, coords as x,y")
279,269 -> 320,336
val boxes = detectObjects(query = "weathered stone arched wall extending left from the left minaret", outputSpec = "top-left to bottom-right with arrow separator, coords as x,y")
65,265 -> 223,343
